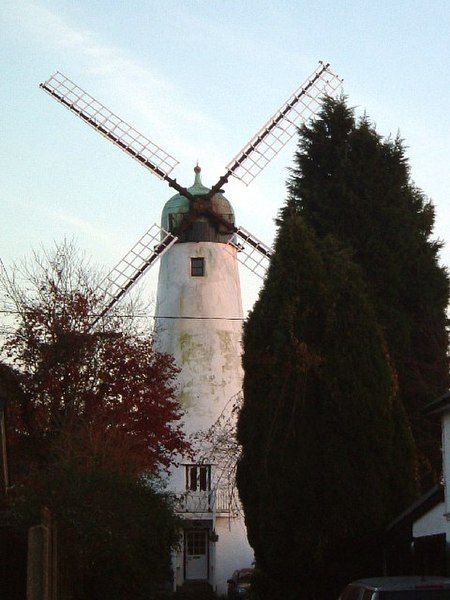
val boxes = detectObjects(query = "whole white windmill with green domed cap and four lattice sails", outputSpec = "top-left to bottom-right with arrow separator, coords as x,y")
40,63 -> 341,594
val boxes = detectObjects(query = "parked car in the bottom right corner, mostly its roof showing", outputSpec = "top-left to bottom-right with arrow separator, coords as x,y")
339,577 -> 450,600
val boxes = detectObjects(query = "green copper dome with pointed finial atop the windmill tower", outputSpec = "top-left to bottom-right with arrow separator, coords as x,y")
161,165 -> 234,237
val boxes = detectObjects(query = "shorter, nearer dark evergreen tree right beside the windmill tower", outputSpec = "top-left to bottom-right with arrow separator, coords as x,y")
238,211 -> 414,600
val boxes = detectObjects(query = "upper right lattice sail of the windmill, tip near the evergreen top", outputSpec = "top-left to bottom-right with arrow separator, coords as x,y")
226,63 -> 342,185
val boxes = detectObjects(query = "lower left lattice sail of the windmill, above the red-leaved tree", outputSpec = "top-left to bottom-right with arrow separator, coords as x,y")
91,223 -> 178,327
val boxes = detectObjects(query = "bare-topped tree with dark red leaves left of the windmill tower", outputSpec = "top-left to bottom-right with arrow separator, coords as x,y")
3,243 -> 187,476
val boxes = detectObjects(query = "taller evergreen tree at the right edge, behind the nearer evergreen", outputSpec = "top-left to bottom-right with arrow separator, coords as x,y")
290,98 -> 450,485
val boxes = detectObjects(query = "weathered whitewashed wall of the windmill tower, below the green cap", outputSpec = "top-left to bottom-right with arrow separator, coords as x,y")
155,242 -> 253,594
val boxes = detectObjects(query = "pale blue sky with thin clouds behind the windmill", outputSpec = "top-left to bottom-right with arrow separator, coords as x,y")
0,0 -> 450,309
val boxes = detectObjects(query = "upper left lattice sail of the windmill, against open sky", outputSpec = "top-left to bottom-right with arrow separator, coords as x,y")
40,71 -> 179,179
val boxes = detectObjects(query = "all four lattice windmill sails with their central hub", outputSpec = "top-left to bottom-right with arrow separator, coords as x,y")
40,62 -> 342,326
